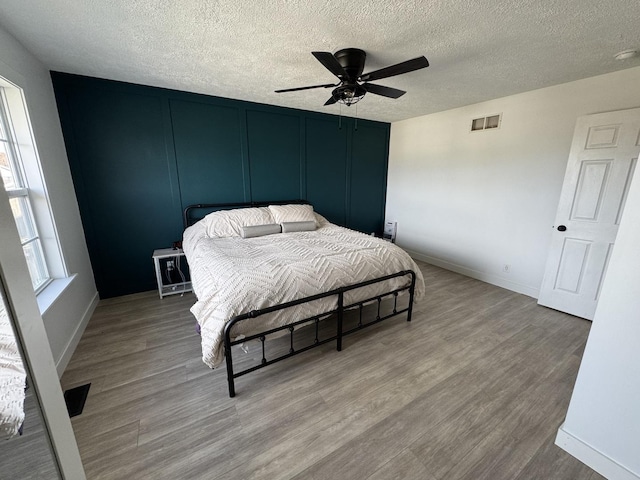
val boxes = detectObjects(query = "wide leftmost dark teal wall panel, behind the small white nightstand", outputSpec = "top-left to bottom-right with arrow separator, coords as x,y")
67,89 -> 175,296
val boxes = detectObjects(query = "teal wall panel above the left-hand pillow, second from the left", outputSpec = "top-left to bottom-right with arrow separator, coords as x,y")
170,99 -> 245,208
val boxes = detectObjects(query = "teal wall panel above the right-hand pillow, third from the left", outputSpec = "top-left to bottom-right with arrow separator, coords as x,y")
247,110 -> 302,202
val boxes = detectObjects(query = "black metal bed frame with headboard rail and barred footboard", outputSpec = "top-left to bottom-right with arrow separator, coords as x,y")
183,200 -> 416,398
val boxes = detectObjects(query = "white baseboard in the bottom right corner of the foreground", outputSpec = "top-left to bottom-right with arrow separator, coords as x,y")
555,424 -> 640,480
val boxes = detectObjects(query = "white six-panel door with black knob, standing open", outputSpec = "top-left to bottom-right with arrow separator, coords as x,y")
538,108 -> 640,320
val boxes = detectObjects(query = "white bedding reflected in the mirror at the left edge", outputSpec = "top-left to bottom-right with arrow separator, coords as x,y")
0,297 -> 27,438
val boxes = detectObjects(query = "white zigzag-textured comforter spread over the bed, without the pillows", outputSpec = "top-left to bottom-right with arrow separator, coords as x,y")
183,221 -> 424,368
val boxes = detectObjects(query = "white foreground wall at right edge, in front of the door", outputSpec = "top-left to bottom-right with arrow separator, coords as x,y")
556,149 -> 640,479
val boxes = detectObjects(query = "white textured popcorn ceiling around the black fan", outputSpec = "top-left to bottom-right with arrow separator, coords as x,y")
0,0 -> 640,122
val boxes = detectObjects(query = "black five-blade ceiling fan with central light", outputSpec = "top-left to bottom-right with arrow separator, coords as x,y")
276,48 -> 429,106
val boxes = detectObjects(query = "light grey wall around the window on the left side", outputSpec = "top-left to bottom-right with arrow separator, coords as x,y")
0,23 -> 98,374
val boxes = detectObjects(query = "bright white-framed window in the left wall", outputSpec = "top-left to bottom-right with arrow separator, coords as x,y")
0,87 -> 51,293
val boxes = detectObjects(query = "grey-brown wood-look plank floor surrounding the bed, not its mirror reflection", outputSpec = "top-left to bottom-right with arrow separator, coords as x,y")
62,263 -> 602,480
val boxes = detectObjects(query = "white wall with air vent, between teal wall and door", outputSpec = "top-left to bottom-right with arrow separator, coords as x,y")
386,63 -> 640,297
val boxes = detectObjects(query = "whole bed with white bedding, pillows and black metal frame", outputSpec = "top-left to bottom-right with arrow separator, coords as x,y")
183,204 -> 424,397
